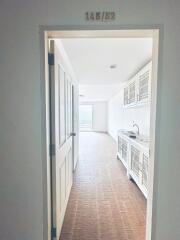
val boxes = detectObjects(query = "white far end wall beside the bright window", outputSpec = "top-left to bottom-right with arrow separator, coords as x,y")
81,101 -> 107,132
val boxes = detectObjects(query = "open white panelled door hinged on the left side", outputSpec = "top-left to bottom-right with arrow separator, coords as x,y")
49,40 -> 73,240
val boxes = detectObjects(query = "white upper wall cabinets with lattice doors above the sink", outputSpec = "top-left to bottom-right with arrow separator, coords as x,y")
124,62 -> 152,106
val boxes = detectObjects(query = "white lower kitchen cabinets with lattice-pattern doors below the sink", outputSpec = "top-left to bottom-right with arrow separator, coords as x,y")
117,134 -> 149,198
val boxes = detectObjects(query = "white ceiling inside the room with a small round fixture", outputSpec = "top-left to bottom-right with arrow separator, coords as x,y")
61,38 -> 152,101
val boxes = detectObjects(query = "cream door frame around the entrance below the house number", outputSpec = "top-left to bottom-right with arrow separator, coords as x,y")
39,24 -> 163,240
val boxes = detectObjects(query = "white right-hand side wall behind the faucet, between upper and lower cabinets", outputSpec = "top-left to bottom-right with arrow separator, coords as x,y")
108,87 -> 150,140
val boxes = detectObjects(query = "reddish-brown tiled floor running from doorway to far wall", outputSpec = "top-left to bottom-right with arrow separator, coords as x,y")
60,132 -> 146,240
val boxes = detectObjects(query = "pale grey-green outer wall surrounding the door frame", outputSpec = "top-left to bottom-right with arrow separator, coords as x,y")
0,0 -> 180,240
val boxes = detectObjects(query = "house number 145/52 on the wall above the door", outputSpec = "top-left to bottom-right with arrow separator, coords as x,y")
85,11 -> 116,22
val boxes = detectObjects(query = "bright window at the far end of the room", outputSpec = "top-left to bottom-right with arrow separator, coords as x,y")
79,104 -> 93,130
